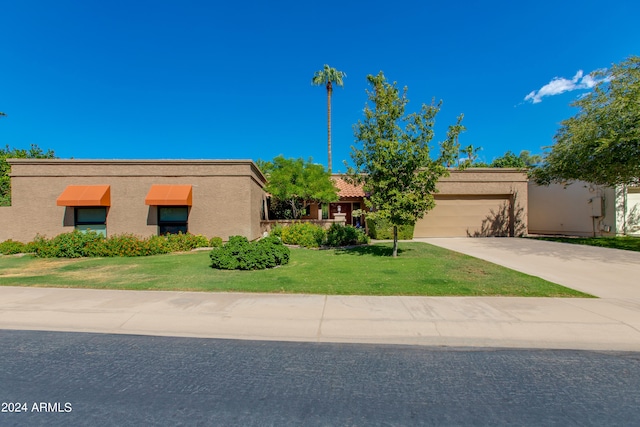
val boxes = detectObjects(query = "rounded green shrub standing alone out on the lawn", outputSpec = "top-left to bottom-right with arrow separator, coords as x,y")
209,236 -> 290,270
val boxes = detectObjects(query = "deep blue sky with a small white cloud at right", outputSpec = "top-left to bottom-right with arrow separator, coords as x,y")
0,0 -> 640,171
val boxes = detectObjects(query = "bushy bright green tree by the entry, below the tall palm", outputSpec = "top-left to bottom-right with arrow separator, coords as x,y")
258,156 -> 339,219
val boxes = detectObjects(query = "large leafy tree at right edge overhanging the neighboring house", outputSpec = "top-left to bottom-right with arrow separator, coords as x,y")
531,56 -> 640,186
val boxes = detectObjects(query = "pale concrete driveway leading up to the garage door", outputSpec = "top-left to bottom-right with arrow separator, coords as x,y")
414,237 -> 640,303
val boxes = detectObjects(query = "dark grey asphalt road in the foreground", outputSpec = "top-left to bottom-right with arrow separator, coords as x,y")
0,330 -> 640,426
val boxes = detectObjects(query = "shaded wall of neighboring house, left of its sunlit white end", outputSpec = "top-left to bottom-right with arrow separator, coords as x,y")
529,181 -> 619,236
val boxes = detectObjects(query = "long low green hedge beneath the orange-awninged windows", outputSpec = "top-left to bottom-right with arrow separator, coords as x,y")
0,230 -> 216,258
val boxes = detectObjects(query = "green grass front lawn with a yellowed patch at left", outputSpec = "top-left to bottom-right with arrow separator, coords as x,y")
0,242 -> 589,297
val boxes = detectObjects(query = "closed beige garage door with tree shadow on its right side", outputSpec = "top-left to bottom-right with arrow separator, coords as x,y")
413,195 -> 510,237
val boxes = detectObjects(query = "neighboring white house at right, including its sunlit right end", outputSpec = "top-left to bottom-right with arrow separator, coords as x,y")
529,181 -> 640,236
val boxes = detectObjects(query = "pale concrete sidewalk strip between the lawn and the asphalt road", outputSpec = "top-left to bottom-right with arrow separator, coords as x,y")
0,287 -> 640,351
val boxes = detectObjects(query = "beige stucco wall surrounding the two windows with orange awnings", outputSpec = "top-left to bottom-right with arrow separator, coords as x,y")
0,159 -> 265,242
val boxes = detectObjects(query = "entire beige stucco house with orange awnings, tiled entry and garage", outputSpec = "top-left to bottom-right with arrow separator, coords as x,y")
0,159 -> 528,242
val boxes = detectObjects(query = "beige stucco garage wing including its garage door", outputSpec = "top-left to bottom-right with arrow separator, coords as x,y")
414,168 -> 528,237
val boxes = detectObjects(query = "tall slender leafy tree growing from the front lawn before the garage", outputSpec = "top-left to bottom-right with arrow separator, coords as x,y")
348,72 -> 464,257
